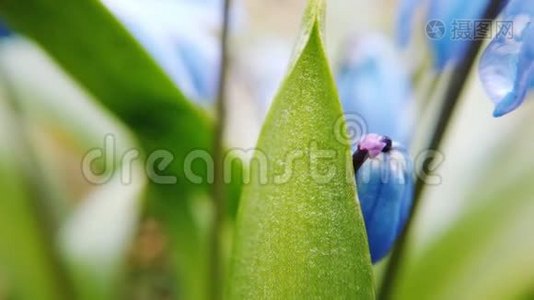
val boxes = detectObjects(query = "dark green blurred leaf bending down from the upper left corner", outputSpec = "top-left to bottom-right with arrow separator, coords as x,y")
0,0 -> 220,298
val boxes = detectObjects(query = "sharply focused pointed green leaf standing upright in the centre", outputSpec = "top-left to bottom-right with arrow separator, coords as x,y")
227,1 -> 374,299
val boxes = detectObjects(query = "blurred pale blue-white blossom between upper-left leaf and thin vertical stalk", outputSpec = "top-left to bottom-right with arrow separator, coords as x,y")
103,0 -> 245,104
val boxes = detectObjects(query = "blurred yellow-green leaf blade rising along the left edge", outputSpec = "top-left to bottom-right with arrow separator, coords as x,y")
0,96 -> 66,300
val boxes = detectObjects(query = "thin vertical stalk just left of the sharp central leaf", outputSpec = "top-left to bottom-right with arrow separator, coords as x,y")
209,0 -> 230,299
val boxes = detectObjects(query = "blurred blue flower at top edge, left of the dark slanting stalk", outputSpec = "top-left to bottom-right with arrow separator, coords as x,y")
397,0 -> 489,70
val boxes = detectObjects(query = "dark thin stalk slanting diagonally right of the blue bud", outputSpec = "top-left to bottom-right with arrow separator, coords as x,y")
378,0 -> 506,299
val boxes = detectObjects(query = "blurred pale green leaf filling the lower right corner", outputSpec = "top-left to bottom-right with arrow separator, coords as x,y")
394,122 -> 534,299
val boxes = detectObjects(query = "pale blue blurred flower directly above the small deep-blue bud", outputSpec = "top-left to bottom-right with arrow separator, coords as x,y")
336,34 -> 414,145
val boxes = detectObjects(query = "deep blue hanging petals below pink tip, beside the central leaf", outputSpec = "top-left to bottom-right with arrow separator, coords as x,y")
356,149 -> 413,263
